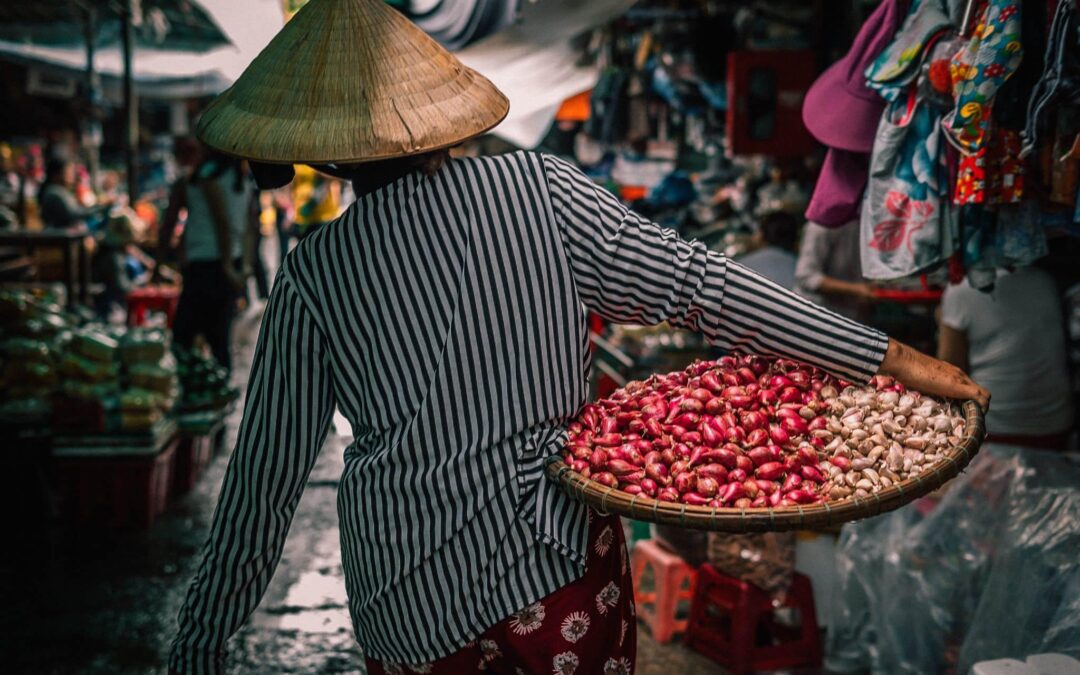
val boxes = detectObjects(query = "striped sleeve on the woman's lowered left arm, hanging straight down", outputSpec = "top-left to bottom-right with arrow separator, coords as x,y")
170,273 -> 335,674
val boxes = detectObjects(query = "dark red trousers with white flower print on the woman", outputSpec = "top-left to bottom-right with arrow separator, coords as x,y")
366,511 -> 637,675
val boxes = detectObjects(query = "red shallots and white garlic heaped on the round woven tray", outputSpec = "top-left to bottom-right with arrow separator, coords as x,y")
564,355 -> 963,509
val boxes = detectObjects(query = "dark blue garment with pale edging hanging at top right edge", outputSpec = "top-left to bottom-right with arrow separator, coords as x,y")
1021,0 -> 1080,157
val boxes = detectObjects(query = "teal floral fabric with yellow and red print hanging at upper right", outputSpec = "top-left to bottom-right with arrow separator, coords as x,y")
942,0 -> 1024,154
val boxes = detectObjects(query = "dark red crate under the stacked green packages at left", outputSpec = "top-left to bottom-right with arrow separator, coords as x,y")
53,419 -> 179,529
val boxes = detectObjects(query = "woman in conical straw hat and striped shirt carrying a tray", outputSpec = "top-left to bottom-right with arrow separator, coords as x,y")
170,0 -> 989,674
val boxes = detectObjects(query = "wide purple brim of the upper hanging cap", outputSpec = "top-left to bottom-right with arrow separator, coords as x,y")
802,59 -> 885,152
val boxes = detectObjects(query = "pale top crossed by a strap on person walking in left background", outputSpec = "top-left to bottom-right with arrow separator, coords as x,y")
184,171 -> 253,262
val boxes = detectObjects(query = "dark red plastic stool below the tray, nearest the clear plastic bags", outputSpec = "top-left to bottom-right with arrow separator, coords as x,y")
686,565 -> 822,674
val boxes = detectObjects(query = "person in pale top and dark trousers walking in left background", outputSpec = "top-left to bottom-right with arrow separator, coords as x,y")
159,146 -> 254,368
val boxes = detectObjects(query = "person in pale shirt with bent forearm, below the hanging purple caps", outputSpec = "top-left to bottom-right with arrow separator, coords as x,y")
795,222 -> 876,321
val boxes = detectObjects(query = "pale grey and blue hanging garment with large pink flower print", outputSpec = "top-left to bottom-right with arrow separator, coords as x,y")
861,86 -> 958,279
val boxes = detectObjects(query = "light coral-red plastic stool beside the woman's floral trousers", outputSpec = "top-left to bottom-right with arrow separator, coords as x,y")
631,539 -> 697,644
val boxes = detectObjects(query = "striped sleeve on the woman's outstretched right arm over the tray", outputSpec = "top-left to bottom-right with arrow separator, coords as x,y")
543,156 -> 888,381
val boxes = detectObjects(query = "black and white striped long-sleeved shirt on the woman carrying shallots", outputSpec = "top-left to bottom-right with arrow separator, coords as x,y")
171,152 -> 887,673
